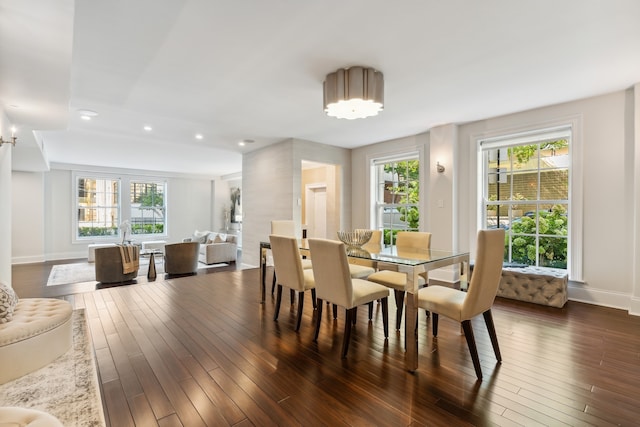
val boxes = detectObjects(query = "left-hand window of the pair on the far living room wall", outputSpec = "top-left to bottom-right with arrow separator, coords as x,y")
76,176 -> 120,239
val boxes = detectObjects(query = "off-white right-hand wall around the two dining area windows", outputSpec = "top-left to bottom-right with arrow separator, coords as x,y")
352,91 -> 640,309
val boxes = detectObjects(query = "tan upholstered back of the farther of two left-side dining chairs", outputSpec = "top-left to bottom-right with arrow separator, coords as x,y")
269,234 -> 304,292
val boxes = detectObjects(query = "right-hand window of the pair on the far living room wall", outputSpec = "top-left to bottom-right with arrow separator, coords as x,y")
129,181 -> 166,236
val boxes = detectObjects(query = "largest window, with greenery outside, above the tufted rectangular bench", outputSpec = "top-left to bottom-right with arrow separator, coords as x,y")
480,127 -> 571,269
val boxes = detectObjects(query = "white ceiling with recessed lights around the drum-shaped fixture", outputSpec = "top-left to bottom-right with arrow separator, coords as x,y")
0,0 -> 640,175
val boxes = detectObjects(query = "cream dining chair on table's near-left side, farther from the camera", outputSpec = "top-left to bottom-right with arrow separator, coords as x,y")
269,234 -> 316,331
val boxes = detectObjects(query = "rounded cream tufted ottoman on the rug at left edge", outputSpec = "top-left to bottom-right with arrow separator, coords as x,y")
0,298 -> 73,384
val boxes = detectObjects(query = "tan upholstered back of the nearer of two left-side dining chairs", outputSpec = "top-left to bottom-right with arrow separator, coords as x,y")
309,239 -> 353,309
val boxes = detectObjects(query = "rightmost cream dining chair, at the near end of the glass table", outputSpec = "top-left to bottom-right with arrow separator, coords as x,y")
418,228 -> 504,380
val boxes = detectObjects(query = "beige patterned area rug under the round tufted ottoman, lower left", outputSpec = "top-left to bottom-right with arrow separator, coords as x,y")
0,309 -> 105,427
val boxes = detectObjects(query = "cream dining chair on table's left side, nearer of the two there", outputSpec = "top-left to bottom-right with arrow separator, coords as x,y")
309,239 -> 389,358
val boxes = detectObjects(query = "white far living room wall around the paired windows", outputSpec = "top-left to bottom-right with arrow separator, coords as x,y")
9,168 -> 222,264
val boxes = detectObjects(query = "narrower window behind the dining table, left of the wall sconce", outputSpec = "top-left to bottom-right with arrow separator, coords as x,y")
372,154 -> 420,245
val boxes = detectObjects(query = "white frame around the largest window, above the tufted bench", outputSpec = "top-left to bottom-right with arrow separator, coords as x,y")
474,116 -> 583,282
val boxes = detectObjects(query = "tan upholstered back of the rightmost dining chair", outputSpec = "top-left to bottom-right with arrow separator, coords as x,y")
461,228 -> 504,320
